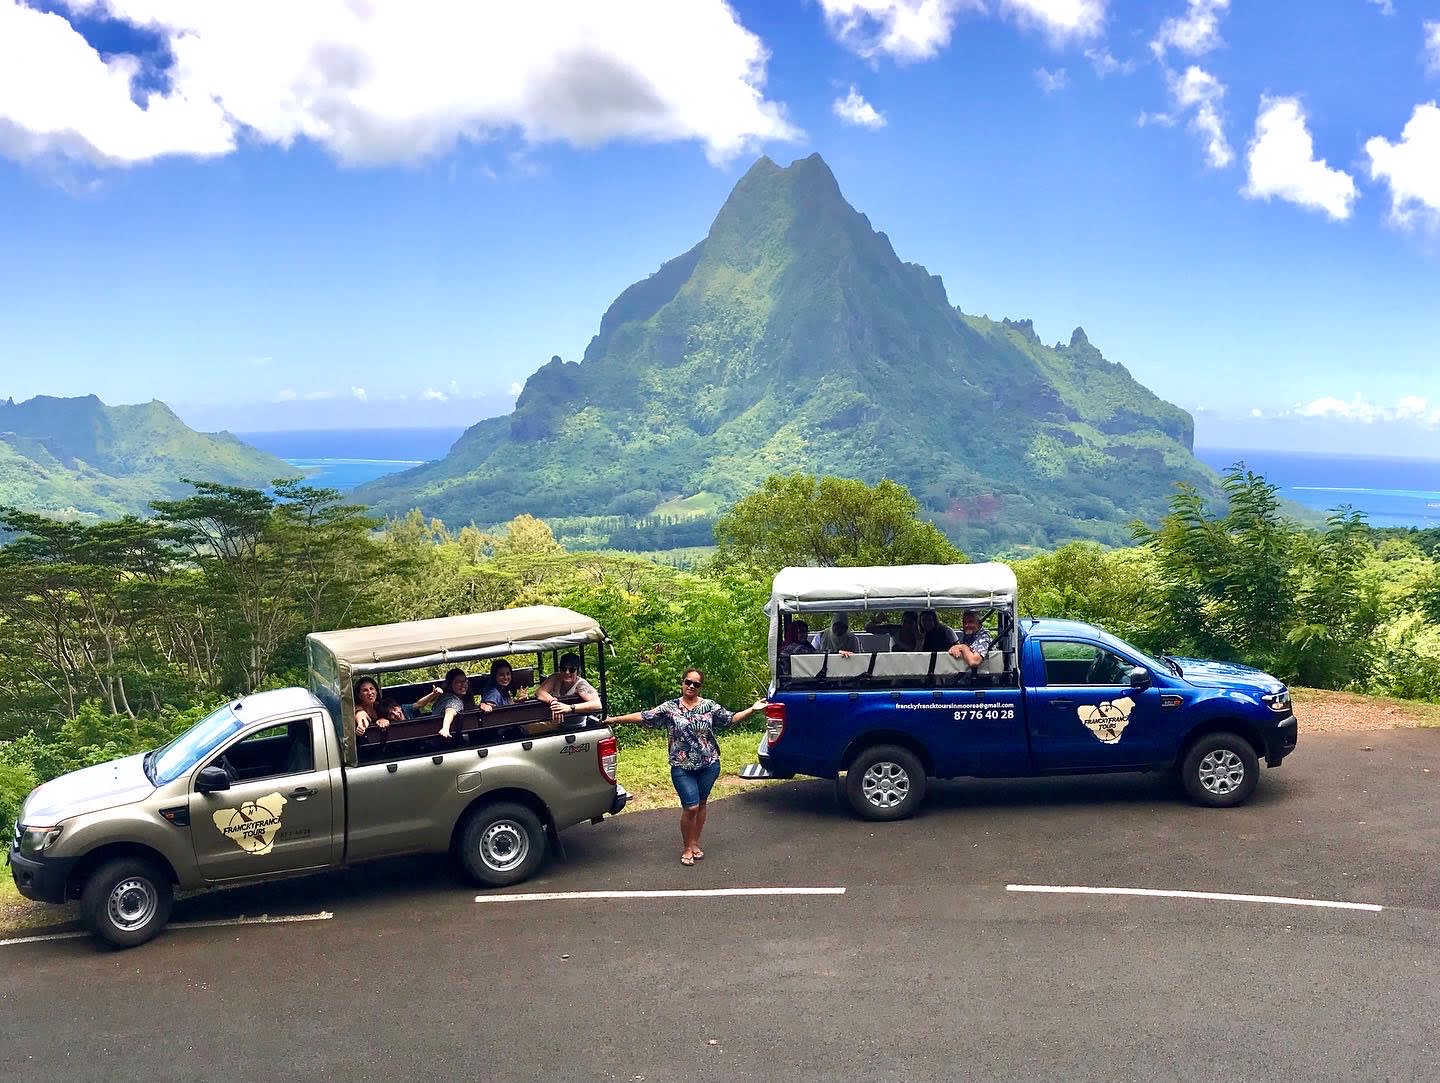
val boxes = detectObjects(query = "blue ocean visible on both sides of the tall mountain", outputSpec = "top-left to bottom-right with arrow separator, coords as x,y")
236,428 -> 1440,527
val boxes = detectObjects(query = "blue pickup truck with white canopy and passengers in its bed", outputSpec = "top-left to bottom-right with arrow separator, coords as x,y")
752,563 -> 1297,819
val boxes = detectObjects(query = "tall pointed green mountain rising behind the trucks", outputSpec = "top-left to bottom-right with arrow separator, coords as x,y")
354,154 -> 1217,552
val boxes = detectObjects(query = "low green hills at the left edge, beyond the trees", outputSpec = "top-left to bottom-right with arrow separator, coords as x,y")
0,395 -> 297,518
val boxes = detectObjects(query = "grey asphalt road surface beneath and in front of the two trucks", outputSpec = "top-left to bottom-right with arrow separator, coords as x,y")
0,730 -> 1440,1080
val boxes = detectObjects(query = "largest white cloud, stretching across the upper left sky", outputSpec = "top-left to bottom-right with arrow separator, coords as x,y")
0,0 -> 799,164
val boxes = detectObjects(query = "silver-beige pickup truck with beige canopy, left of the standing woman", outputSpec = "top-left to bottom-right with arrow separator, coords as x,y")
9,606 -> 628,946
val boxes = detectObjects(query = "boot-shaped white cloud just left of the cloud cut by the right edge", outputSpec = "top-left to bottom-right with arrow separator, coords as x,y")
1241,96 -> 1359,220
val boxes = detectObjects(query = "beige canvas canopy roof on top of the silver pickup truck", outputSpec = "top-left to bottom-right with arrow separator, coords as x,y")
305,605 -> 605,674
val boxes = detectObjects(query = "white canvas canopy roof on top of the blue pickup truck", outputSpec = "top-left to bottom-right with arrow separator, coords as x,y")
770,563 -> 1015,614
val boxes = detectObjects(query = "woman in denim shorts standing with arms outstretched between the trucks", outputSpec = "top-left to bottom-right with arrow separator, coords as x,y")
605,670 -> 765,866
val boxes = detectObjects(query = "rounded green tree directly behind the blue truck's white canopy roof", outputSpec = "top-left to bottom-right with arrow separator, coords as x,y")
714,474 -> 965,576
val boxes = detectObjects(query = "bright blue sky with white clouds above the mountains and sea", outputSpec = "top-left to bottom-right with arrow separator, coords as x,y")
0,0 -> 1440,457
